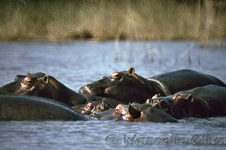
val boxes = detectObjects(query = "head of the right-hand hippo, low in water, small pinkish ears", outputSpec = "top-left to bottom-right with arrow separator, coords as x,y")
147,94 -> 193,119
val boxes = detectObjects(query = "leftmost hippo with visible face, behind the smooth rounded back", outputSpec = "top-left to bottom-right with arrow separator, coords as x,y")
0,72 -> 87,106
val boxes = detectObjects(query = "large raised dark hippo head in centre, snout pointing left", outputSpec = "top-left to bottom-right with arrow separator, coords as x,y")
79,68 -> 154,103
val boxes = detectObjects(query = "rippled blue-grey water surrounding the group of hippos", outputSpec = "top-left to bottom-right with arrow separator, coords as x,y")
0,41 -> 226,150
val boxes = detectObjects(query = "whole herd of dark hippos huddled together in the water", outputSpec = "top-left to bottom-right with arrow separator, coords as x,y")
0,68 -> 226,122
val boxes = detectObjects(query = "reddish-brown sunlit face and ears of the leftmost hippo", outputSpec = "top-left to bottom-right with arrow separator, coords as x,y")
15,72 -> 49,96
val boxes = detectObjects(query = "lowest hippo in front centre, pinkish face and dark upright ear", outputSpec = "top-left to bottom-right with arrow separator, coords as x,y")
90,103 -> 177,123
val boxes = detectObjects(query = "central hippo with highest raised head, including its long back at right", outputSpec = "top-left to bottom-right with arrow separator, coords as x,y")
79,68 -> 225,104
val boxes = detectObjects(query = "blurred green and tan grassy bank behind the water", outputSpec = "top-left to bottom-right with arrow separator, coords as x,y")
0,0 -> 226,42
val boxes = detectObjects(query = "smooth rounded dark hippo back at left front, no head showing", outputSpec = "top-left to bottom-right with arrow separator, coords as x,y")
0,95 -> 87,121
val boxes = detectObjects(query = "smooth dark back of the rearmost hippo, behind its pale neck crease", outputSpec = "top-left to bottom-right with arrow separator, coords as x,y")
148,69 -> 225,95
